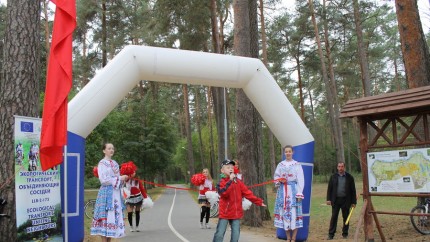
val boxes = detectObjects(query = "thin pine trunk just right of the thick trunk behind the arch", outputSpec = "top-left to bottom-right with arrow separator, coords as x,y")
259,0 -> 276,183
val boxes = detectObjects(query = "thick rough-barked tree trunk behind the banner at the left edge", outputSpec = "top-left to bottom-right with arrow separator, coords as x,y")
0,0 -> 41,241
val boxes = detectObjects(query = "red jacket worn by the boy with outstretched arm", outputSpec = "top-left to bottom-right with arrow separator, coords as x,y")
217,177 -> 263,219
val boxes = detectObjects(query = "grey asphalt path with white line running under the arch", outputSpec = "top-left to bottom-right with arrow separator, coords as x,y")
121,185 -> 280,242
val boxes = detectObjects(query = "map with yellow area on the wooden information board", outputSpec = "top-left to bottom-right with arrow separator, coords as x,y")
367,148 -> 430,193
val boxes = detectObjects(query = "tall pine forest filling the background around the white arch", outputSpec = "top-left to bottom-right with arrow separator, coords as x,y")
0,0 -> 430,238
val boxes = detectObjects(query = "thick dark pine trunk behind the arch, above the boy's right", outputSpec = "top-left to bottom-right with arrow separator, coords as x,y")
233,0 -> 262,226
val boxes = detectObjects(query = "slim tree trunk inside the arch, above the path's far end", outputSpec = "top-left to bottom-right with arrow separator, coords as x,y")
182,84 -> 195,181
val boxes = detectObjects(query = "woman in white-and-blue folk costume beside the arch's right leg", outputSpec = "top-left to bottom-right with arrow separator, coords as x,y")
274,145 -> 305,241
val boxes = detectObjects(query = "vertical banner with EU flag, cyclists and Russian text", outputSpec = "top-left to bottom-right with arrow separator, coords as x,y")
14,116 -> 63,241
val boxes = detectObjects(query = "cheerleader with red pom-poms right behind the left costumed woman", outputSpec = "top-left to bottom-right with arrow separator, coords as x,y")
121,161 -> 148,232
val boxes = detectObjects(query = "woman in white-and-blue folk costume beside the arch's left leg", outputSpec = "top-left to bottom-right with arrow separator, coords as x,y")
91,143 -> 128,242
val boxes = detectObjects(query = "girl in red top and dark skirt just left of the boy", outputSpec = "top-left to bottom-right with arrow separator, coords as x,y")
198,168 -> 214,229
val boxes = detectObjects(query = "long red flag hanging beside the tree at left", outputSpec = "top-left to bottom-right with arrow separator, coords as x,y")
40,0 -> 76,171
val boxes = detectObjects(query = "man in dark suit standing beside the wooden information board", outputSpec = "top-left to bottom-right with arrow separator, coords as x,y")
327,162 -> 357,240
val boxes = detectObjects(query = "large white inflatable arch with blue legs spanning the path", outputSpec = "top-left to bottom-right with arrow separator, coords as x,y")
63,46 -> 314,241
